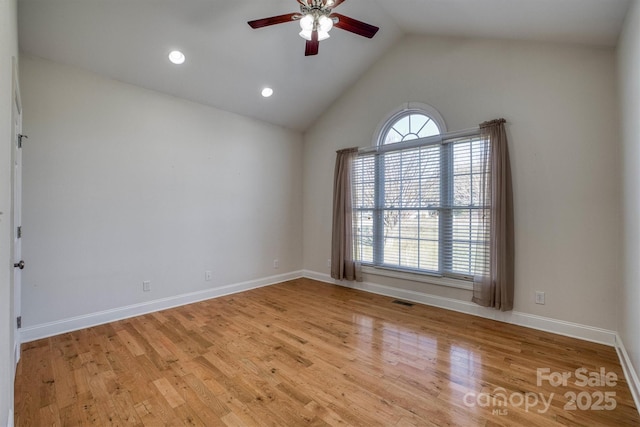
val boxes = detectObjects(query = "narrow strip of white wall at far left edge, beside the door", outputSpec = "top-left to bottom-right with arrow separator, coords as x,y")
0,0 -> 18,425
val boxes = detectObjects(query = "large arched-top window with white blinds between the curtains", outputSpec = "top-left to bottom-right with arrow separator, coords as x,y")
353,111 -> 488,277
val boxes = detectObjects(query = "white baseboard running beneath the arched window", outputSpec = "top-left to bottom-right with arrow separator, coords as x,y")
302,270 -> 616,347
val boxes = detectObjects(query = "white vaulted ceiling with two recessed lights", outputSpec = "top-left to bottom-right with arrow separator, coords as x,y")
18,0 -> 631,131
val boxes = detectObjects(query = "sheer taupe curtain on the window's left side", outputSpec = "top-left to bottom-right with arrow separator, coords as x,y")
331,148 -> 362,282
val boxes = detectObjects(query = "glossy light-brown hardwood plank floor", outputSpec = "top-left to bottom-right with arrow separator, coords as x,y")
15,279 -> 640,427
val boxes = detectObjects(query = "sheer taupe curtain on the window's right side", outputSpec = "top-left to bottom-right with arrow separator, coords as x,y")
472,119 -> 515,311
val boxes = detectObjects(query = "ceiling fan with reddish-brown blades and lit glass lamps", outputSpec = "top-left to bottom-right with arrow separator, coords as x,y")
247,0 -> 379,56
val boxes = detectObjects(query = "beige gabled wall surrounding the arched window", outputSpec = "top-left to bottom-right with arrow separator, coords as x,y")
303,36 -> 621,330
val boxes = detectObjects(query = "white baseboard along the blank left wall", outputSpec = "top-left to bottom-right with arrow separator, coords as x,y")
20,271 -> 302,343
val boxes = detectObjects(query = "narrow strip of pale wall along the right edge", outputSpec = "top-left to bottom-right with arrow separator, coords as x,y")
618,1 -> 640,392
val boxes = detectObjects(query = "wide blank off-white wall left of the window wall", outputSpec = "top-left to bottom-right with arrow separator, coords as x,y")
21,57 -> 302,327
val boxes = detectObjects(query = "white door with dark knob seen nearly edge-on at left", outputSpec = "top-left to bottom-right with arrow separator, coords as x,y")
11,65 -> 24,366
